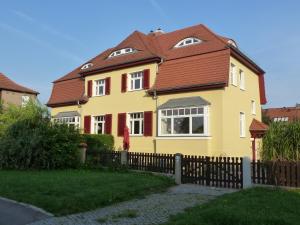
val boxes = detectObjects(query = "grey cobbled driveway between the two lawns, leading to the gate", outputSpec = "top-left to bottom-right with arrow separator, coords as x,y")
30,184 -> 235,225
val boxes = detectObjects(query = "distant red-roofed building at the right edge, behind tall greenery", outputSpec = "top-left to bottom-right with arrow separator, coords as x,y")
263,104 -> 300,122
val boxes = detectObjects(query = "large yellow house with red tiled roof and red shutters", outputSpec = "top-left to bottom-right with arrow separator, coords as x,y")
48,25 -> 266,156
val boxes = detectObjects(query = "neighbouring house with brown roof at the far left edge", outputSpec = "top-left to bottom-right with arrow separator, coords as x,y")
0,73 -> 39,107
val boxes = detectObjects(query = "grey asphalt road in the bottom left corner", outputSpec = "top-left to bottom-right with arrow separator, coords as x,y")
0,198 -> 50,225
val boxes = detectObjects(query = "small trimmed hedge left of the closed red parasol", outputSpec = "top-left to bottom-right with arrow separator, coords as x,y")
82,134 -> 114,152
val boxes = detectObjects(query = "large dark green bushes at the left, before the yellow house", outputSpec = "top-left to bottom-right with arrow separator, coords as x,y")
0,102 -> 81,169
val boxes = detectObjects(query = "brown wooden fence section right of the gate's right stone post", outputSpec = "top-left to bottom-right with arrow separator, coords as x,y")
251,160 -> 300,187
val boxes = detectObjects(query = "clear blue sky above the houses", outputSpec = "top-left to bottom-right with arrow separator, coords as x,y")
0,0 -> 300,107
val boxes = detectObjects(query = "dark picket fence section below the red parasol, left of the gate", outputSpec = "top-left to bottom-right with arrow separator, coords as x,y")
127,152 -> 175,174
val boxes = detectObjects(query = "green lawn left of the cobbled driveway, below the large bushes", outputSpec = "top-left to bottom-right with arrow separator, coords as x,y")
0,170 -> 174,215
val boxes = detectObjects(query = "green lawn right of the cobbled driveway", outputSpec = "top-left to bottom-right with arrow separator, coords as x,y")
166,188 -> 300,225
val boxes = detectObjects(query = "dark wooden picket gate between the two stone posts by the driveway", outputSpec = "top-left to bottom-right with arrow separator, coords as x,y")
181,155 -> 243,188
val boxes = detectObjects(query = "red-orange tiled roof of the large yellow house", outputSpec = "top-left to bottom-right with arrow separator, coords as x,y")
48,25 -> 265,106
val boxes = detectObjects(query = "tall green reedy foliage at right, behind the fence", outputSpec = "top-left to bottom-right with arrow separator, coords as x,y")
261,121 -> 300,160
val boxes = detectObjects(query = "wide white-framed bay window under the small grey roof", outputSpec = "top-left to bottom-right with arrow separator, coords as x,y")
158,106 -> 208,136
